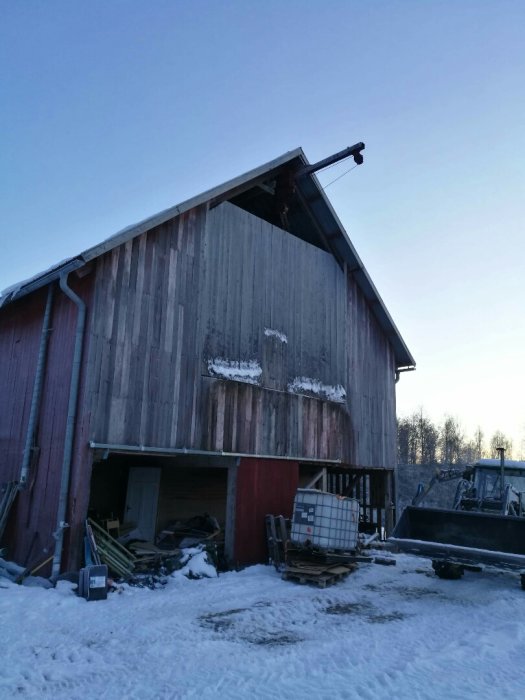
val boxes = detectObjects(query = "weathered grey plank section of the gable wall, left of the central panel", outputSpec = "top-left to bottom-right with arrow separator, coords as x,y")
88,209 -> 206,447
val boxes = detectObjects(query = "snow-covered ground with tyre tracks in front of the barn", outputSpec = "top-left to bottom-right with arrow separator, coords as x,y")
0,555 -> 525,700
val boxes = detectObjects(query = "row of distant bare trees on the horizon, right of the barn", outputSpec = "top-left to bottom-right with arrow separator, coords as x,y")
397,409 -> 513,464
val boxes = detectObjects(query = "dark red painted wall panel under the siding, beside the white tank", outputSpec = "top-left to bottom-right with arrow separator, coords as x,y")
235,458 -> 299,564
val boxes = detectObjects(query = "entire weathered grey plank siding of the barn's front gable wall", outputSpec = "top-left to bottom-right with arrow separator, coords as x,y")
88,203 -> 395,467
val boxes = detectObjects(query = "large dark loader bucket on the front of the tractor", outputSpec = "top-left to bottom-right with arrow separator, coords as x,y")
389,506 -> 525,571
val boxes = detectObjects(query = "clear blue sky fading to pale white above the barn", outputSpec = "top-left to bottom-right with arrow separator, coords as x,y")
0,0 -> 525,458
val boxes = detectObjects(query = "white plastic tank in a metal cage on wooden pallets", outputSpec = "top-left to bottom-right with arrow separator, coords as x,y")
290,489 -> 359,551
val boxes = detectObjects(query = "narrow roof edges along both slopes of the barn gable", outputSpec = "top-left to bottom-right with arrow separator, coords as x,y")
0,148 -> 415,367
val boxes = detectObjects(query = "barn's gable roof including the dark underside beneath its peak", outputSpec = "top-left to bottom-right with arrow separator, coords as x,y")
0,148 -> 415,368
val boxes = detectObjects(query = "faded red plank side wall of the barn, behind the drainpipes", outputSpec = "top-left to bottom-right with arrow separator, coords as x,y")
0,275 -> 92,575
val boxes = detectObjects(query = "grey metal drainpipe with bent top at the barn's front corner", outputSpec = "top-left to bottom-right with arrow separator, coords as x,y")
51,272 -> 86,579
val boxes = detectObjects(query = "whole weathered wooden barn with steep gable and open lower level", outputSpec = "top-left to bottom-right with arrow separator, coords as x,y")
0,144 -> 414,573
